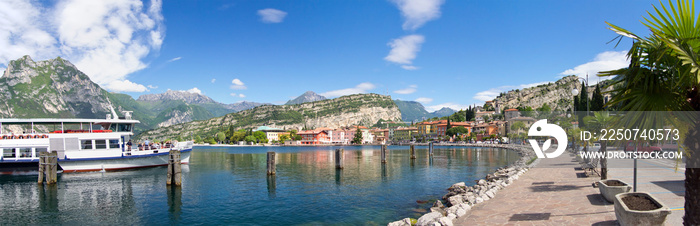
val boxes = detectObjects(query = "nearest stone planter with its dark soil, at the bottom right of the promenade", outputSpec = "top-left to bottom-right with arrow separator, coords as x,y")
615,192 -> 671,226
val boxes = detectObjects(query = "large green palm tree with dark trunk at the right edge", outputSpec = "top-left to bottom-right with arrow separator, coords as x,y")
599,0 -> 700,225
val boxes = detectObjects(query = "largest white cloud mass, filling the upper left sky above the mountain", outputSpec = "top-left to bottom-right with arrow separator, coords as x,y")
0,0 -> 165,92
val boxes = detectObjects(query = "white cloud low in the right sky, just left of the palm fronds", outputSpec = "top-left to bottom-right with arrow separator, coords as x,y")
559,51 -> 629,79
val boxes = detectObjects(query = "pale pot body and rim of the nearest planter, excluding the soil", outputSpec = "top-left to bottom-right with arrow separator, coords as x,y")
615,192 -> 671,226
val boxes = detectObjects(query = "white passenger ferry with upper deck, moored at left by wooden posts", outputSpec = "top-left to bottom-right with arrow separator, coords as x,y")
0,110 -> 192,174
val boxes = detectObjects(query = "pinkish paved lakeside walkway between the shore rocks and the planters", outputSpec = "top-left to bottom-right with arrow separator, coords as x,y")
455,152 -> 617,225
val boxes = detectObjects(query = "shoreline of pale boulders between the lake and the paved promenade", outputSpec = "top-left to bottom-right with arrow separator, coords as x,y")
388,144 -> 539,226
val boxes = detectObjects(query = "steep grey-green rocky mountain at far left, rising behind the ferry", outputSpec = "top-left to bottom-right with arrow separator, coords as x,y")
0,56 -> 109,118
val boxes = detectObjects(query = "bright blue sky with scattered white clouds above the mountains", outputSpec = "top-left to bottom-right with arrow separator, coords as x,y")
0,0 -> 659,111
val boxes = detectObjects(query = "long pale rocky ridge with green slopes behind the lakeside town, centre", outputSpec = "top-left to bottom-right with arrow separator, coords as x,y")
141,94 -> 401,139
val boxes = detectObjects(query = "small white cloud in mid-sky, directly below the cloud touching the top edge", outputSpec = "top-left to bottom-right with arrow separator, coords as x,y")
384,35 -> 425,67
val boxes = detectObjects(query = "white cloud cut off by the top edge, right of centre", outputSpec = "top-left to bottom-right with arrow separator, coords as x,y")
392,0 -> 444,31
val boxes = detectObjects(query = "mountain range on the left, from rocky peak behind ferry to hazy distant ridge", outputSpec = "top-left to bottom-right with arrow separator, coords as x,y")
0,56 -> 264,133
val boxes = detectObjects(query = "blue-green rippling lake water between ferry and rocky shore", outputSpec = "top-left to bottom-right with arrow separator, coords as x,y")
0,146 -> 519,225
